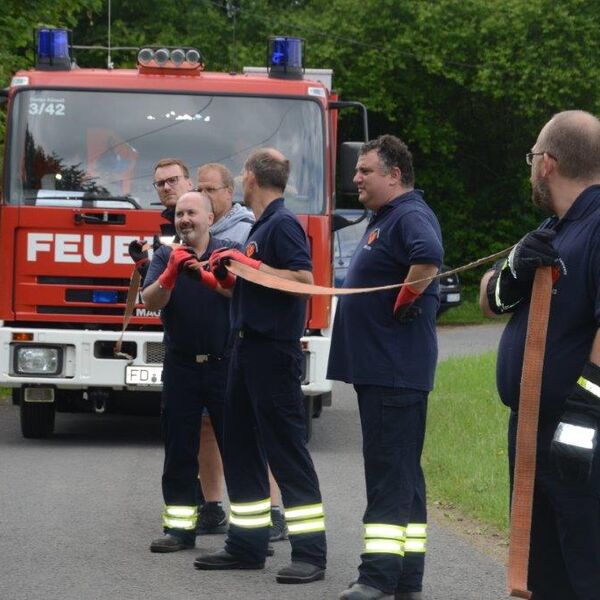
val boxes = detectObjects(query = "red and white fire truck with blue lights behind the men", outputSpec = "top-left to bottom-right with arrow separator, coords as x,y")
0,29 -> 366,438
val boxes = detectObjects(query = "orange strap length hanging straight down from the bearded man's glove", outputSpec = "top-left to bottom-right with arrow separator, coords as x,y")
507,267 -> 552,598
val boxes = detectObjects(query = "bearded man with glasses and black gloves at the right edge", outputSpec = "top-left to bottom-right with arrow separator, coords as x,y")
480,111 -> 600,600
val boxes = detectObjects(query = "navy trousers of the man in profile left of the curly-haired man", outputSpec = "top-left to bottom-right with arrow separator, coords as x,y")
223,338 -> 326,567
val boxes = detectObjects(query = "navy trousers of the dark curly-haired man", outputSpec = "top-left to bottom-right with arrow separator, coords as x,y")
354,385 -> 428,594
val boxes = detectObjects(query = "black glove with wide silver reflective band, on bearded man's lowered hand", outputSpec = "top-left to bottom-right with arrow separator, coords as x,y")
550,362 -> 600,485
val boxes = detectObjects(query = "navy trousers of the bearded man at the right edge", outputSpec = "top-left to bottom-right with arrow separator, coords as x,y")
508,412 -> 600,600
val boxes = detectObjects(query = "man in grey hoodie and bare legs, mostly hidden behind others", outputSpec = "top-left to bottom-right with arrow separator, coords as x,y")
197,163 -> 287,542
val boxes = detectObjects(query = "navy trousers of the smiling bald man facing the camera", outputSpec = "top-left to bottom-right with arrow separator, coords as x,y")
161,353 -> 228,540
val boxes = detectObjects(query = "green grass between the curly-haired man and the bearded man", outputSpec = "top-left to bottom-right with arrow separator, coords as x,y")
423,352 -> 508,532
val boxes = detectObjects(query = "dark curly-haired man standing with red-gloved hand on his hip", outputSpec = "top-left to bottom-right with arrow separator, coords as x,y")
327,135 -> 443,600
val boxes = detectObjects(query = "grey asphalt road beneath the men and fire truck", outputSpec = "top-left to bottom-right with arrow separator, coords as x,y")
0,325 -> 506,600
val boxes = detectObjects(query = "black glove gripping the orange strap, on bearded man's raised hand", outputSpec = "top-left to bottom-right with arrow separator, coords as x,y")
508,229 -> 560,284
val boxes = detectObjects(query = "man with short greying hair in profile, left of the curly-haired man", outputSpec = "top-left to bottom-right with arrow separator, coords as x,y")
194,149 -> 326,583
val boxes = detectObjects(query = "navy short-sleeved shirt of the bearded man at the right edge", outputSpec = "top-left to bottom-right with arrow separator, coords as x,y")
496,185 -> 600,419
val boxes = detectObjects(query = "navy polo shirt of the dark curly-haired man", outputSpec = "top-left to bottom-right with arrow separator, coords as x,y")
327,190 -> 444,391
